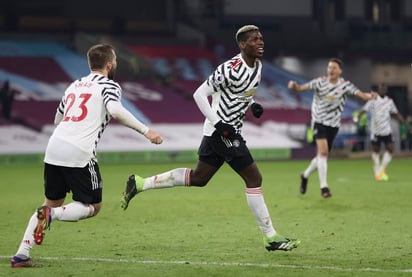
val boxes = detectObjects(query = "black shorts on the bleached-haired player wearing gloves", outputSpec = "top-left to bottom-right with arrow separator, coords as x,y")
197,133 -> 254,172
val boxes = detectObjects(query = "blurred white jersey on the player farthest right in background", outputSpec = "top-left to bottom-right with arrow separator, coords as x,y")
362,96 -> 398,137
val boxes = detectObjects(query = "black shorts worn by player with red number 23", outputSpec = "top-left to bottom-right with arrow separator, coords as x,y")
44,161 -> 103,204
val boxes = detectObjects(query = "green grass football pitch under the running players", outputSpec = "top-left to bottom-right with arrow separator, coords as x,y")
0,157 -> 412,277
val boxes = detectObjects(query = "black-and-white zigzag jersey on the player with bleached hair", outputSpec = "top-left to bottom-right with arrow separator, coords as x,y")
204,54 -> 262,136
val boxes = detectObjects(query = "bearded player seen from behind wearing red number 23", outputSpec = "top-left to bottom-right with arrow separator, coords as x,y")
11,44 -> 163,267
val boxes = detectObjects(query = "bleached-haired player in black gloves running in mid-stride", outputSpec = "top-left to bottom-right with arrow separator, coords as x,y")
121,25 -> 299,251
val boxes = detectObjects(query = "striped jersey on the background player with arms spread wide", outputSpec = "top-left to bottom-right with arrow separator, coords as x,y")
308,77 -> 359,127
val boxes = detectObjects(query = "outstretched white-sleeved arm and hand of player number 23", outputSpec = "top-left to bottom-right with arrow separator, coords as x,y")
106,101 -> 163,144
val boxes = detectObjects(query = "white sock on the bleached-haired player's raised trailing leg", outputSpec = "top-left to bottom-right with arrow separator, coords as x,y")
143,168 -> 192,190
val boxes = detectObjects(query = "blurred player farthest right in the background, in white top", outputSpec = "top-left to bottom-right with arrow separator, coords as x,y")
358,83 -> 404,181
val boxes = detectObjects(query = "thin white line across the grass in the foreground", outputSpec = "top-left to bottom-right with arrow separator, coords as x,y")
0,256 -> 412,273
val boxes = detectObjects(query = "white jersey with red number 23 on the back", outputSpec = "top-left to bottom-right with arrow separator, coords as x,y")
44,73 -> 121,167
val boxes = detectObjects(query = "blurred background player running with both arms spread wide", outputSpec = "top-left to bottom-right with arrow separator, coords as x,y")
288,58 -> 377,198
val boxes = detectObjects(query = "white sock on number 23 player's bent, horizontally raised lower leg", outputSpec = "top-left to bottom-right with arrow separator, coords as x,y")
52,201 -> 94,221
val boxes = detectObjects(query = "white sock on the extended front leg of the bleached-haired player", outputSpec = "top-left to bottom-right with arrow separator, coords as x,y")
246,187 -> 276,237
